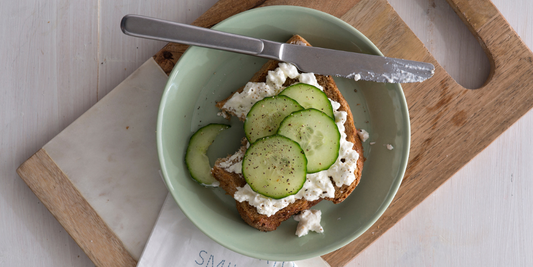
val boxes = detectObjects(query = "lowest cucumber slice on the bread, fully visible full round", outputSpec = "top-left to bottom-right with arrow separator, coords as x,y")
242,135 -> 307,199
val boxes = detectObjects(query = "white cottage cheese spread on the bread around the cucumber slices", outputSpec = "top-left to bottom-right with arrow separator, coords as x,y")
221,63 -> 359,216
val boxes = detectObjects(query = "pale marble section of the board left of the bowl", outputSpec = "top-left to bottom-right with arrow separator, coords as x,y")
44,58 -> 168,259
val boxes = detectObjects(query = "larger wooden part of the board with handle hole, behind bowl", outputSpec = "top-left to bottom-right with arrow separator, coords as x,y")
151,0 -> 533,266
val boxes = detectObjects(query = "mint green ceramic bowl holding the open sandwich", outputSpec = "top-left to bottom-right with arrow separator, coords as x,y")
157,6 -> 410,261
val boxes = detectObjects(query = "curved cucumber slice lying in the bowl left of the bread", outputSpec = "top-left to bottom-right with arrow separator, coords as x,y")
185,123 -> 230,186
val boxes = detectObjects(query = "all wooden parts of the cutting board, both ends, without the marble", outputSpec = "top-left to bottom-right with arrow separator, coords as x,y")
18,0 -> 533,266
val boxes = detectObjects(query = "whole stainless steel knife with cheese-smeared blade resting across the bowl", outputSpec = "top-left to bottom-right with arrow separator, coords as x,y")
120,15 -> 435,83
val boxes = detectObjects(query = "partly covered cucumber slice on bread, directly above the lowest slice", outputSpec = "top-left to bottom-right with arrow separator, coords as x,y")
244,96 -> 303,143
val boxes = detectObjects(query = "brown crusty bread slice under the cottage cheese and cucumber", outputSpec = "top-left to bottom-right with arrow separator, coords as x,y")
212,35 -> 364,231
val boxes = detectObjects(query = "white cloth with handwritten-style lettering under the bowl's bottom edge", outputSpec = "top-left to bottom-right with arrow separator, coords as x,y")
137,193 -> 329,267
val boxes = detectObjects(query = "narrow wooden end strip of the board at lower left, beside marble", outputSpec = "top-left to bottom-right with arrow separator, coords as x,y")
17,151 -> 137,266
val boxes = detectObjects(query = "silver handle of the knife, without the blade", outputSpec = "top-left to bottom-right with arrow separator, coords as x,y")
120,15 -> 264,55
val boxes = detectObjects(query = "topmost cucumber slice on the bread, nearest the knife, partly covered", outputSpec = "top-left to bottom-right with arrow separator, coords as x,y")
279,83 -> 335,119
